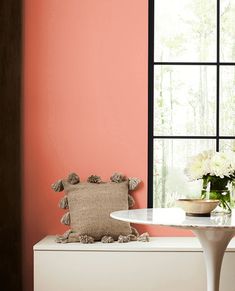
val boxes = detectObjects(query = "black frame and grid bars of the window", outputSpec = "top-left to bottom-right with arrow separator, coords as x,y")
147,0 -> 235,208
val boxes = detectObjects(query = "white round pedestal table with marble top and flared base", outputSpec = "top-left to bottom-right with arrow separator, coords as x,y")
110,208 -> 235,291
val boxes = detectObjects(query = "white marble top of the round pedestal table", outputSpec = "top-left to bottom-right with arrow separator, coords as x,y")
110,208 -> 235,229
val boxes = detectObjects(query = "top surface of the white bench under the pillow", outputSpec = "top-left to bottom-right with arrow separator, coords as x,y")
33,236 -> 235,252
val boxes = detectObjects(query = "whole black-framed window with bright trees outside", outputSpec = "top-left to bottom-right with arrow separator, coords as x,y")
148,0 -> 235,207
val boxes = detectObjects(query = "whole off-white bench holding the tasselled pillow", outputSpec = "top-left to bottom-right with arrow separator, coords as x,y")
34,236 -> 235,291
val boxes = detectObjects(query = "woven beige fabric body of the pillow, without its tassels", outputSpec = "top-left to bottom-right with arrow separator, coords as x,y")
63,181 -> 131,240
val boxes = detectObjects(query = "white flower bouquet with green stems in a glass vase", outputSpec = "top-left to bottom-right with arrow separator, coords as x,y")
185,151 -> 235,212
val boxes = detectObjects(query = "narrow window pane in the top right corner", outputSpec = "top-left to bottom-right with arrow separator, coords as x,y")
220,0 -> 235,62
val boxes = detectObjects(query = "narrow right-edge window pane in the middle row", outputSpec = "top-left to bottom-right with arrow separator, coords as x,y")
220,66 -> 235,136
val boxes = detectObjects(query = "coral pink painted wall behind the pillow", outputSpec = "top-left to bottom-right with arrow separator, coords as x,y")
23,0 -> 189,291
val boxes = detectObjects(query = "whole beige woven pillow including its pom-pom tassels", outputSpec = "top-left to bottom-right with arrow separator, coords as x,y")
51,173 -> 141,243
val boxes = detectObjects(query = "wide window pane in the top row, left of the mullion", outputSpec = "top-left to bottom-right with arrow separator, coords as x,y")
154,0 -> 216,62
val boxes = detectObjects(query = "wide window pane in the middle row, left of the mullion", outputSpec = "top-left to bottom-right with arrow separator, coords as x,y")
154,65 -> 216,136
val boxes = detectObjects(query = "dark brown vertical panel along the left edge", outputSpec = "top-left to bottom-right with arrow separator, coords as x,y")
0,0 -> 22,291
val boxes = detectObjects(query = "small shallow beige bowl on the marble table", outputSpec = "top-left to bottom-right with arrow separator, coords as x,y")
176,198 -> 220,216
